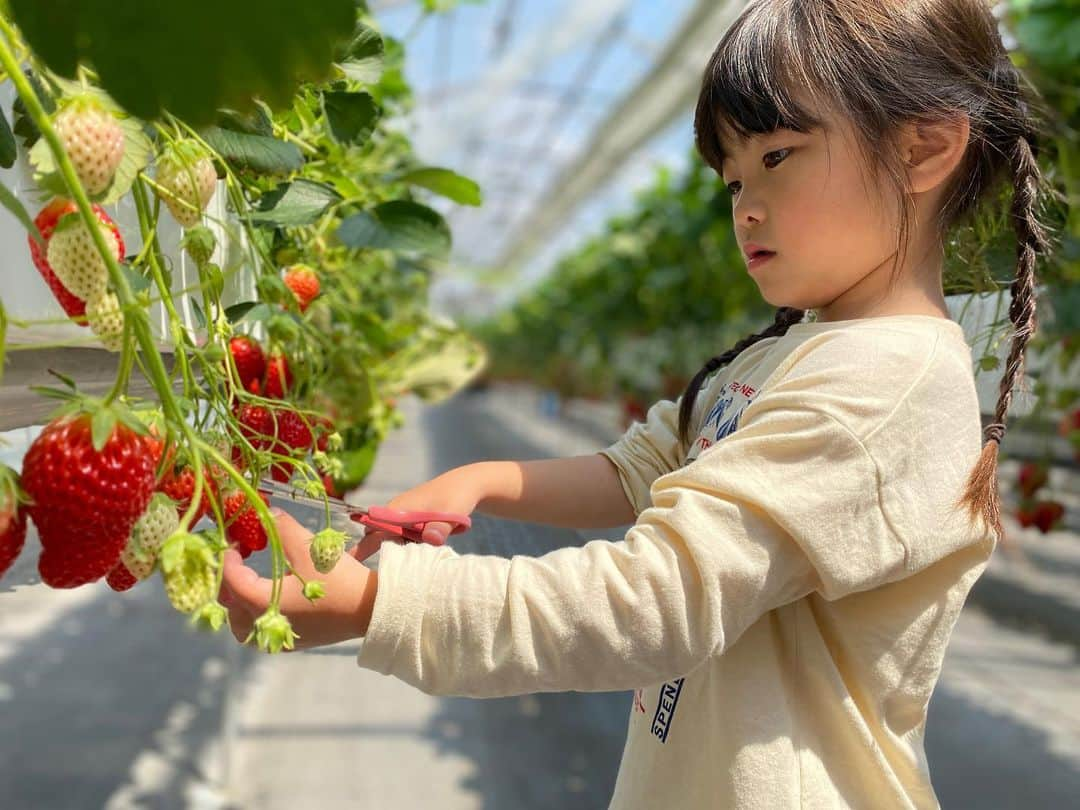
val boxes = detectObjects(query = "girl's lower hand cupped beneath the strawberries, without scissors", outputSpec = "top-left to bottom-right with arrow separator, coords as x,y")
219,510 -> 378,649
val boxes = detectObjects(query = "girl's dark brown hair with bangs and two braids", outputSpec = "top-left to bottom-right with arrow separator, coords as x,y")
679,0 -> 1049,546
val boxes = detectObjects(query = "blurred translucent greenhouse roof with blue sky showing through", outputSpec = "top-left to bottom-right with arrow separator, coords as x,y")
373,0 -> 743,317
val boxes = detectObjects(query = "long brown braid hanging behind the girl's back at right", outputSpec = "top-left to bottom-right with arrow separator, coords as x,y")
962,134 -> 1049,548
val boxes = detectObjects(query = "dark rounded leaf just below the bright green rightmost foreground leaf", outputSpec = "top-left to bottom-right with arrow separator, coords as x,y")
337,200 -> 450,258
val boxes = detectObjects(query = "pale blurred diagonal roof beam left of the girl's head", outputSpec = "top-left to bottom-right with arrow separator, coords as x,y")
494,0 -> 747,273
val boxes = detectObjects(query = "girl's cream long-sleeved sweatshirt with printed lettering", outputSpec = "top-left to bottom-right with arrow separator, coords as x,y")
357,315 -> 998,810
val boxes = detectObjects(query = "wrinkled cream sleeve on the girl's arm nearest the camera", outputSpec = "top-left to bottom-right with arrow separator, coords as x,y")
357,387 -> 906,697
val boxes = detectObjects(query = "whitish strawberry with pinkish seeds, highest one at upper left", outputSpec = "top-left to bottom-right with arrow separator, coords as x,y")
53,96 -> 124,194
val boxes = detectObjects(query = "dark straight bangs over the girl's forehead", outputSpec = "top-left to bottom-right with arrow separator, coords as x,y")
693,2 -> 821,174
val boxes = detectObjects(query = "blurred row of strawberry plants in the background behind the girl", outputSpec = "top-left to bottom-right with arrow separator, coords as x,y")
472,0 -> 1080,540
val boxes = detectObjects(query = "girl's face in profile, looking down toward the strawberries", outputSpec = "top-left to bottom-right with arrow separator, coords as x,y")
721,106 -> 920,321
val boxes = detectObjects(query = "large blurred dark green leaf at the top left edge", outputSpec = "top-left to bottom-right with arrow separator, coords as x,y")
10,0 -> 356,126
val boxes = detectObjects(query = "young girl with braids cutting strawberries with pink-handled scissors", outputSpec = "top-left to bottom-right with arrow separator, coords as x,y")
225,0 -> 1045,810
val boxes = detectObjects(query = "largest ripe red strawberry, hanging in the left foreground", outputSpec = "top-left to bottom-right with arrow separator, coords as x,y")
23,413 -> 154,588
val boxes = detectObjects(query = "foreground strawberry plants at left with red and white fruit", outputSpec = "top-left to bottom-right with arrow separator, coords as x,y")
0,0 -> 484,651
